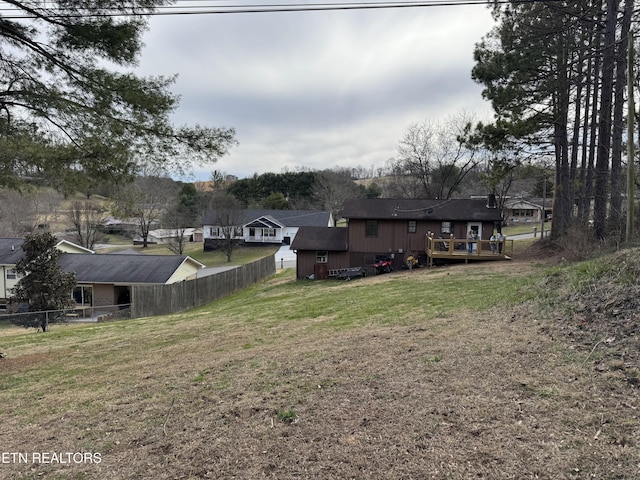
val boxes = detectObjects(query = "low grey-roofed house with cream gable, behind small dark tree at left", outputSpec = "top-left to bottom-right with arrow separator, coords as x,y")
0,238 -> 204,310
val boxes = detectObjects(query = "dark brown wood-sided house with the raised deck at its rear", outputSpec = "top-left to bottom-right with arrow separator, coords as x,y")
292,198 -> 502,278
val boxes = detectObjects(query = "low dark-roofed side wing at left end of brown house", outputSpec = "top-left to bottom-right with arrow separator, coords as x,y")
291,227 -> 349,279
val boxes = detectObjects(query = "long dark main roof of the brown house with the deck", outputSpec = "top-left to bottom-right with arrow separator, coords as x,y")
342,198 -> 502,222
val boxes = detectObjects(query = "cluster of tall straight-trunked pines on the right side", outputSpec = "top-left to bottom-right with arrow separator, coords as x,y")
472,0 -> 638,239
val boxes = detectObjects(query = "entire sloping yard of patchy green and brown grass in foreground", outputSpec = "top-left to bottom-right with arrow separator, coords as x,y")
0,251 -> 640,479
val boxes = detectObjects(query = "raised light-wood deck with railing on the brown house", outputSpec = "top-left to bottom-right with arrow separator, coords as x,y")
425,233 -> 513,267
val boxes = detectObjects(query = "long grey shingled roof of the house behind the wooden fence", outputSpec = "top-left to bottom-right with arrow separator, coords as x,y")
58,253 -> 204,285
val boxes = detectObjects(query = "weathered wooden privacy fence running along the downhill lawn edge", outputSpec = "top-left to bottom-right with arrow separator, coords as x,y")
131,256 -> 276,318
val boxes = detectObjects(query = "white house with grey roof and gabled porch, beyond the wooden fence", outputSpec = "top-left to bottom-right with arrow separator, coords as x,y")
203,209 -> 333,250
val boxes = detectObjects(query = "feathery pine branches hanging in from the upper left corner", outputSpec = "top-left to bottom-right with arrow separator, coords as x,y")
0,0 -> 235,193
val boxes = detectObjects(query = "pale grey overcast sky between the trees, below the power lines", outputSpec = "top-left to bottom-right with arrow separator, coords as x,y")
138,5 -> 492,180
